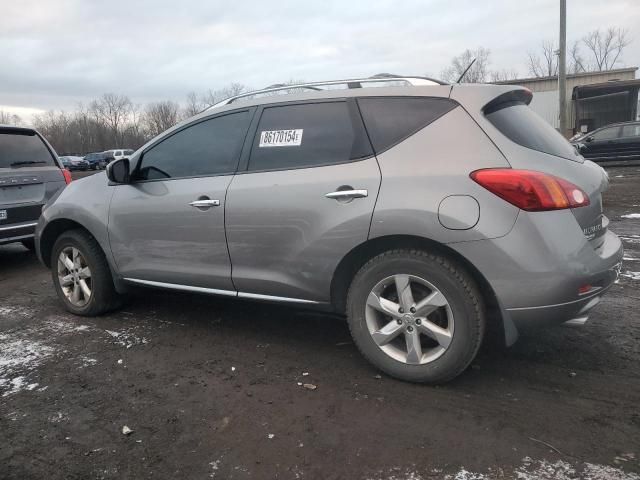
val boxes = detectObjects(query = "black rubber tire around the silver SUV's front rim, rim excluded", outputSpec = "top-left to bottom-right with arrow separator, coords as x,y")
51,230 -> 122,317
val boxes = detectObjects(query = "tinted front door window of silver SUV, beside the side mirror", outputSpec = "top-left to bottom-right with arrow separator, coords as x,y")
136,112 -> 249,180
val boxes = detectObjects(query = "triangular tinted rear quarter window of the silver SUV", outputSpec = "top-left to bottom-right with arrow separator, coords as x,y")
358,97 -> 456,153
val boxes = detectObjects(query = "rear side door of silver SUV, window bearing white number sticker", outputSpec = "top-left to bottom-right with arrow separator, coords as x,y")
226,100 -> 380,302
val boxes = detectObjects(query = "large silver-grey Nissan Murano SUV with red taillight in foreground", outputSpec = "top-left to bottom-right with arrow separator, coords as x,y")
32,79 -> 622,383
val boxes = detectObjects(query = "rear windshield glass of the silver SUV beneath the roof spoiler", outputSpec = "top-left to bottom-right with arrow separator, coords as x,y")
486,102 -> 578,160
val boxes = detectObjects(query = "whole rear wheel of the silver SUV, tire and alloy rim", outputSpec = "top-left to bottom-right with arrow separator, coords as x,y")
347,250 -> 485,383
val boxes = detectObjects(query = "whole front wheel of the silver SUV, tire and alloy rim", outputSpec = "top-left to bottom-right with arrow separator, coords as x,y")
51,230 -> 121,317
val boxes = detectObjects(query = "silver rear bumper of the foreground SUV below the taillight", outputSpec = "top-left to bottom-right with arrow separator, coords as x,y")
452,210 -> 623,329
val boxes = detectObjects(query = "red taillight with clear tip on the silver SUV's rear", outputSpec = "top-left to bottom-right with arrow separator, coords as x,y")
471,168 -> 589,212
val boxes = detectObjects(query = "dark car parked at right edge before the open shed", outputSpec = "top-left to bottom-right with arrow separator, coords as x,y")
571,122 -> 640,163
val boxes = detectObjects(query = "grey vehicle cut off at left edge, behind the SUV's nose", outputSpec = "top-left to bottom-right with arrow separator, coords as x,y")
0,125 -> 71,250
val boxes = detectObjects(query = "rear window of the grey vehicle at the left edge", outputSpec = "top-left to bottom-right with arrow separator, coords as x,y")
0,129 -> 55,168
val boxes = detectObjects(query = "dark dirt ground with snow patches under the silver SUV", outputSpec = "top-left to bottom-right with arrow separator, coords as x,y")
0,167 -> 640,480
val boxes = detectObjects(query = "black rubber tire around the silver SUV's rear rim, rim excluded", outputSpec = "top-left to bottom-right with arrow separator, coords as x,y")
347,250 -> 485,384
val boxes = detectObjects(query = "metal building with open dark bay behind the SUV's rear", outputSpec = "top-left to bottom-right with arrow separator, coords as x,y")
496,67 -> 640,137
